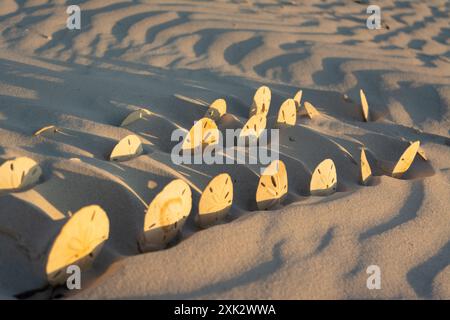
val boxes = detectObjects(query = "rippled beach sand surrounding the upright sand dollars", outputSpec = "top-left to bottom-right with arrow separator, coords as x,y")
0,0 -> 450,299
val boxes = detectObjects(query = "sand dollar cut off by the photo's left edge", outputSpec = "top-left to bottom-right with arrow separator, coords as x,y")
0,157 -> 42,191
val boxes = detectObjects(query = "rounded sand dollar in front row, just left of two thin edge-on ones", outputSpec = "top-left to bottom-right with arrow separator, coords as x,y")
309,159 -> 337,196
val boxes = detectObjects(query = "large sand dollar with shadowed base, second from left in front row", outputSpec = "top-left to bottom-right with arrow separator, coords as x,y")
139,179 -> 192,251
